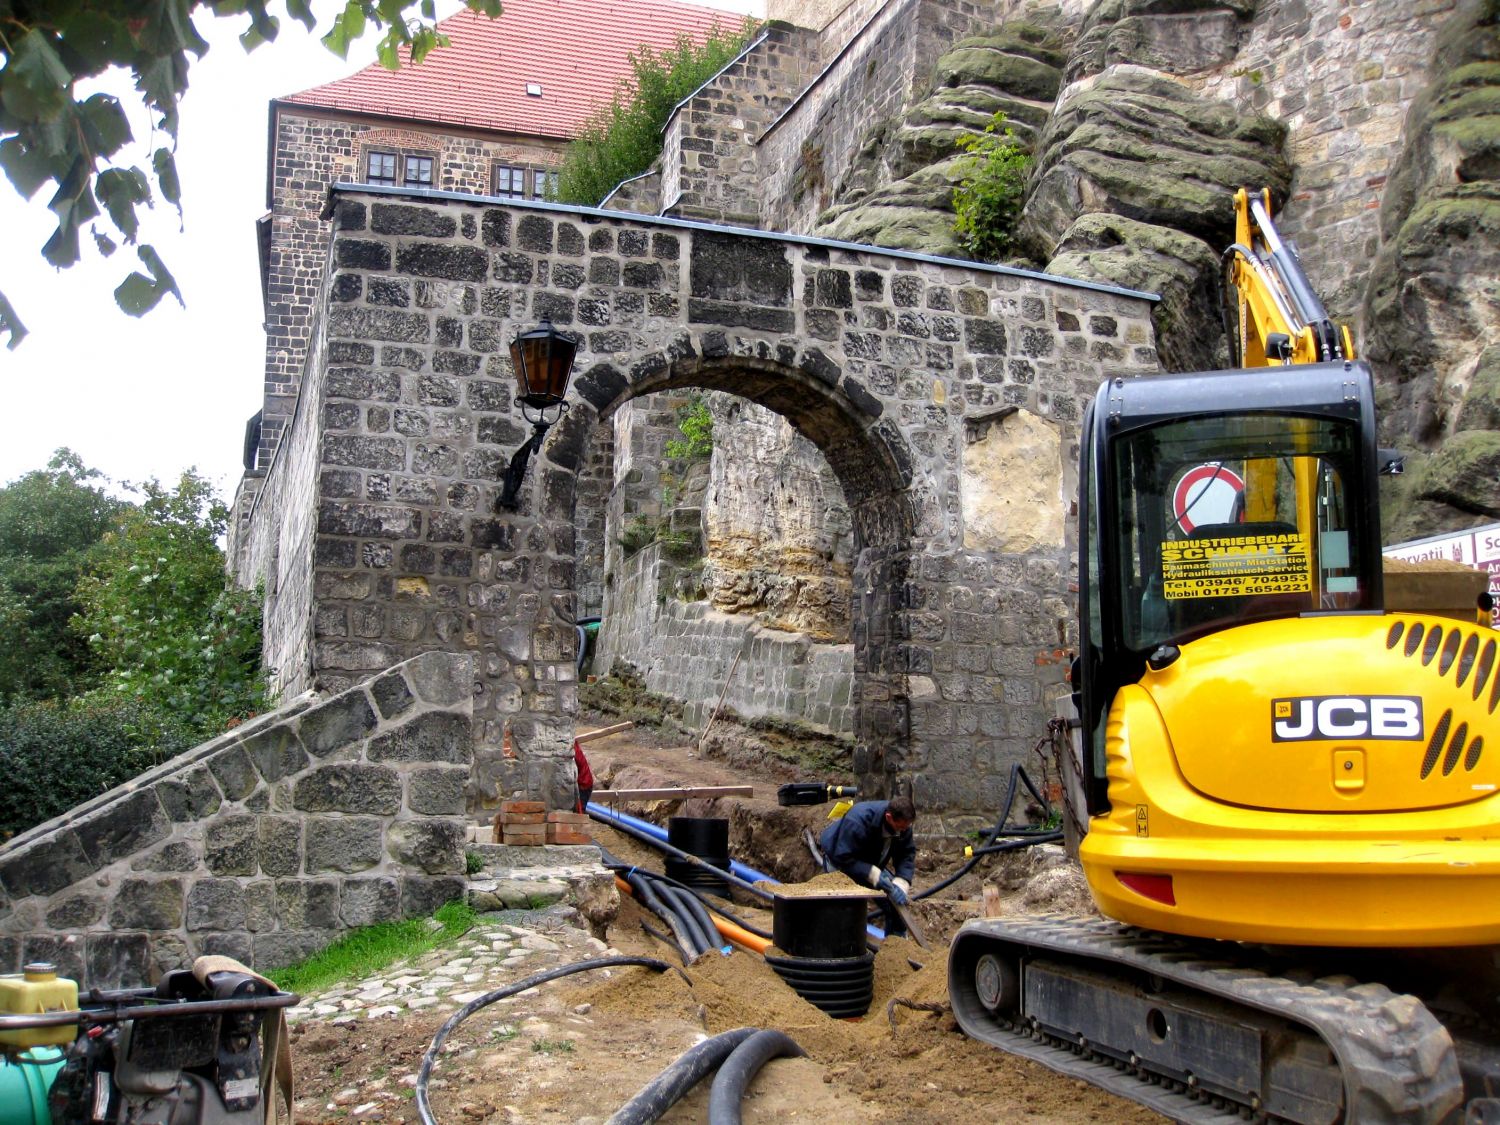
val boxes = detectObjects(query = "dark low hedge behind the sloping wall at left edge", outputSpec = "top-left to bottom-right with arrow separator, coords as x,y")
0,696 -> 197,837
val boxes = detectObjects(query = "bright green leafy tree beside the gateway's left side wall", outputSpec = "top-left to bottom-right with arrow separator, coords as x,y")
75,470 -> 267,738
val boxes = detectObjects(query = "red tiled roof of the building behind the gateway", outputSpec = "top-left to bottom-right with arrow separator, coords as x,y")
282,0 -> 744,138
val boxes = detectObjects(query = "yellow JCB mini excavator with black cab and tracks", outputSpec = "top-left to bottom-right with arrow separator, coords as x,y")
950,192 -> 1500,1125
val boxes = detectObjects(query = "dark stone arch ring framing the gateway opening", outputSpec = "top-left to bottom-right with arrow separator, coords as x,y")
543,339 -> 920,795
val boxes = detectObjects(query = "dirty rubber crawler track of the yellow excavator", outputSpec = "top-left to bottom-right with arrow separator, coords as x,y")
948,918 -> 1464,1125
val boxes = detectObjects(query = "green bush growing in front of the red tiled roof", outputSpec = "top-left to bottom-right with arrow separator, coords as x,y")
557,20 -> 756,206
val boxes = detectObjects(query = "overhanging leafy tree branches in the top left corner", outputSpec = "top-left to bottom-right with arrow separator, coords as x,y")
0,0 -> 500,348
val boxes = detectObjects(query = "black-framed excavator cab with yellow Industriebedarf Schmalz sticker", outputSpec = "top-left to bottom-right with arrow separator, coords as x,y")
1076,363 -> 1382,813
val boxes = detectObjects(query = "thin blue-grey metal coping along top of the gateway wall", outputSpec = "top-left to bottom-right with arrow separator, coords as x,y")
320,183 -> 1161,302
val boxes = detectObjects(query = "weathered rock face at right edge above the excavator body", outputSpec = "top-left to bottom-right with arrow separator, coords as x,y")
1367,0 -> 1500,539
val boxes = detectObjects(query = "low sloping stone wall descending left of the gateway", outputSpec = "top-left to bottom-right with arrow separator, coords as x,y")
0,653 -> 474,989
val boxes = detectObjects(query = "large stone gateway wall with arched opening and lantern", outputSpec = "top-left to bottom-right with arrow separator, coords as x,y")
233,186 -> 1157,813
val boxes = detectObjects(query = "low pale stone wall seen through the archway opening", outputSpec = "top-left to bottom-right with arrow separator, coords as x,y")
594,543 -> 855,737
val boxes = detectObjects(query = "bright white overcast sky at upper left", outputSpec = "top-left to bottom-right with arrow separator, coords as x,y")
0,0 -> 764,500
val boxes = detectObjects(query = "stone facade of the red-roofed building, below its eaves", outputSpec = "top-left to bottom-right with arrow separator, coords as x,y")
258,102 -> 563,470
